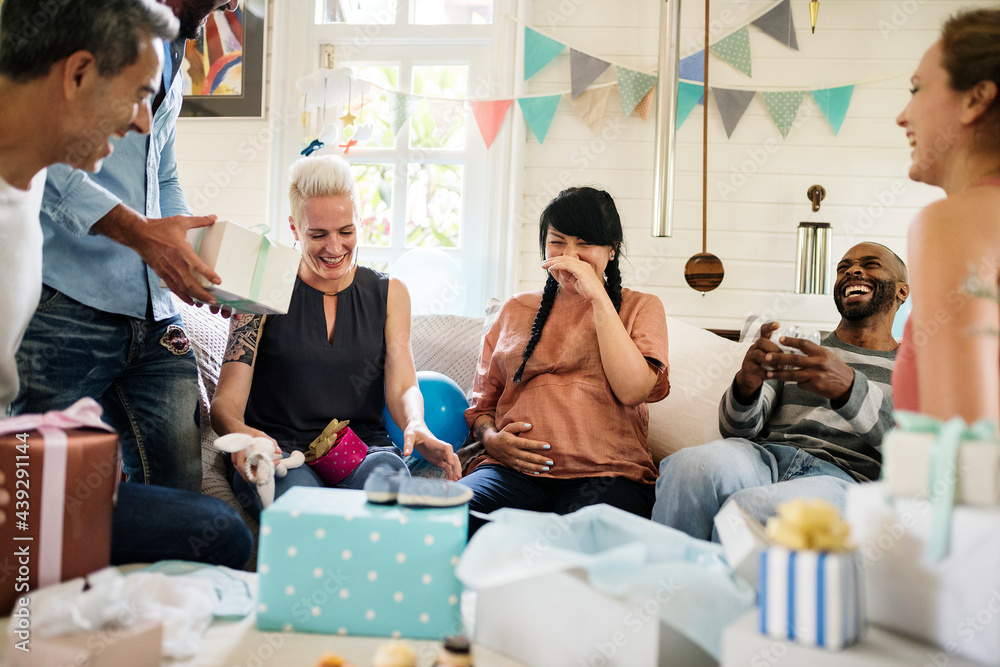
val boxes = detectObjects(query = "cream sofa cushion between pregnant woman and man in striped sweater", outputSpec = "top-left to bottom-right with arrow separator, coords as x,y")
649,316 -> 750,465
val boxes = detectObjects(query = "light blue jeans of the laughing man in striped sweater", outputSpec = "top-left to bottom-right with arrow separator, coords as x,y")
653,438 -> 855,542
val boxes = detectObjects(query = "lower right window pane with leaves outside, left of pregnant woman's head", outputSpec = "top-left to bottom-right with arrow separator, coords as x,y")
406,164 -> 463,248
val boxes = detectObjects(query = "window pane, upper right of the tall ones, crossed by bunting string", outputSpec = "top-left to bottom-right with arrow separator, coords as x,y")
410,65 -> 469,150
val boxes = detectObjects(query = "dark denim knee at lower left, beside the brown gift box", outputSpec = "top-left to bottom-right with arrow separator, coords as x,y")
111,482 -> 253,569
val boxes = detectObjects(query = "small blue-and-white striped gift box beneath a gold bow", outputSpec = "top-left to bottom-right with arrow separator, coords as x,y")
758,546 -> 866,649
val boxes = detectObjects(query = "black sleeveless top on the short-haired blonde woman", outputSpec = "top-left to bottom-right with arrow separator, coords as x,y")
244,266 -> 395,451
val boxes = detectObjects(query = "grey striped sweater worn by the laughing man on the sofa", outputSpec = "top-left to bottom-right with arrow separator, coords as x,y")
719,333 -> 896,482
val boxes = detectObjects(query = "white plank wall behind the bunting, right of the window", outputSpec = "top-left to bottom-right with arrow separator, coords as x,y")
515,0 -> 996,328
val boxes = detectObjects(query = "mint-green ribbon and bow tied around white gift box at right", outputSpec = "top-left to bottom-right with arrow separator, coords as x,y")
895,410 -> 1000,563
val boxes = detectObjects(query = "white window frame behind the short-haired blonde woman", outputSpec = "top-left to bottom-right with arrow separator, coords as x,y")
269,0 -> 520,315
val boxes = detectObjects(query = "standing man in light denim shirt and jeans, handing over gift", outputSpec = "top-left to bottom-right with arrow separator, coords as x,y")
13,0 -> 238,491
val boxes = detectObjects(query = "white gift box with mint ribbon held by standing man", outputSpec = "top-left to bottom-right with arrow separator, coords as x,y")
191,220 -> 302,315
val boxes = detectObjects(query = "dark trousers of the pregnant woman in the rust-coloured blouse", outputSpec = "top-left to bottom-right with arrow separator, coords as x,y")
461,464 -> 653,538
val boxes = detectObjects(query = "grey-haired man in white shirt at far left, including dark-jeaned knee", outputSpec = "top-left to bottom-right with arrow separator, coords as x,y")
0,0 -> 253,569
